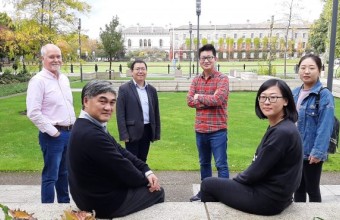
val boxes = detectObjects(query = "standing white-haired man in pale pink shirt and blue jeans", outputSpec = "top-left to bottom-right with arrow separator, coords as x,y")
26,44 -> 76,203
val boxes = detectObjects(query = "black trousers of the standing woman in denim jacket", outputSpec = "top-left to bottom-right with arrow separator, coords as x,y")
294,160 -> 323,202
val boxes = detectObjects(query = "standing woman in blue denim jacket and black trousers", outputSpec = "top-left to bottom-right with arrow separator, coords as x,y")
293,54 -> 334,202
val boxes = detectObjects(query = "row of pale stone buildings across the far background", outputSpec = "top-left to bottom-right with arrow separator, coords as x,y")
122,21 -> 310,60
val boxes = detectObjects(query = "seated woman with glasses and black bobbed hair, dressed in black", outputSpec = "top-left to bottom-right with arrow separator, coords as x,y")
201,79 -> 302,215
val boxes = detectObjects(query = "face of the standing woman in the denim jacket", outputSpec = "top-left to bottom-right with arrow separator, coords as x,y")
299,58 -> 320,89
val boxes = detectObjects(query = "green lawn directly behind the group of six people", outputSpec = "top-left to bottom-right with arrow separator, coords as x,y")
0,92 -> 340,172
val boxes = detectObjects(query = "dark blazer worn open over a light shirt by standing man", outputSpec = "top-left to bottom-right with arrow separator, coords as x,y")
116,80 -> 161,142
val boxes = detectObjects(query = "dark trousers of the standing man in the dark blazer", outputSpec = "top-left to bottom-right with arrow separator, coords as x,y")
125,124 -> 152,162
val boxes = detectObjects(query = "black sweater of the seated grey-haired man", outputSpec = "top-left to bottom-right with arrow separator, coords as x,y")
67,118 -> 150,218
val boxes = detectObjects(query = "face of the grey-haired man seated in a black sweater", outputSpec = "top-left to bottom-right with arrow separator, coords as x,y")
84,92 -> 116,123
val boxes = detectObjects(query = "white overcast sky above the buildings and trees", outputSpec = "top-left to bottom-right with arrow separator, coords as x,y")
0,0 -> 323,38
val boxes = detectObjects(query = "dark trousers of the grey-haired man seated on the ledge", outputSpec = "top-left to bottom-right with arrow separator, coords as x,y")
112,187 -> 164,217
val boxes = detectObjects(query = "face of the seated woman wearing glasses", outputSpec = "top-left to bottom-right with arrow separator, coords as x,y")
258,86 -> 288,121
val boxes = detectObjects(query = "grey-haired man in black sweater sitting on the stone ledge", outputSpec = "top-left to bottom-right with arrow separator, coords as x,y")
67,80 -> 164,218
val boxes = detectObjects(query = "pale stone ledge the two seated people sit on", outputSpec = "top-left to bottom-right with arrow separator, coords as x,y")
0,202 -> 340,220
